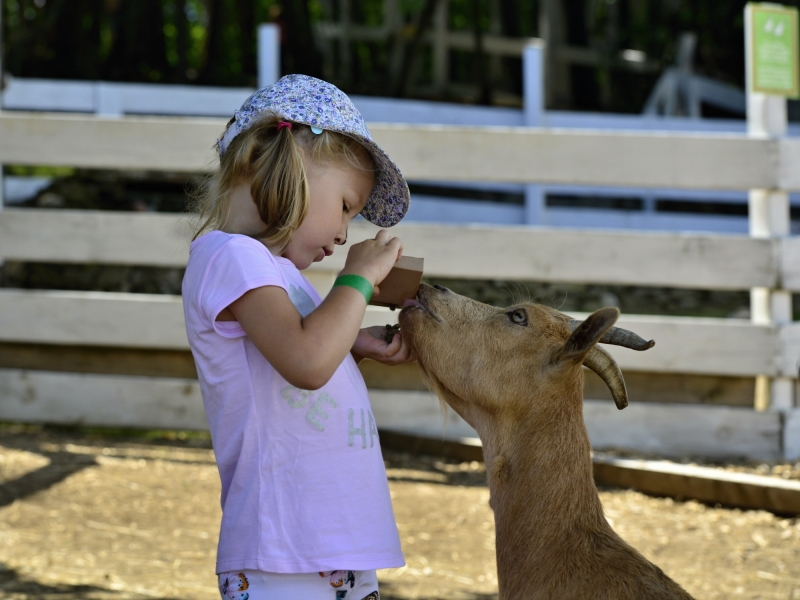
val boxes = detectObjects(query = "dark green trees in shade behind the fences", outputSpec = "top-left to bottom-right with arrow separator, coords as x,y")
2,0 -> 800,112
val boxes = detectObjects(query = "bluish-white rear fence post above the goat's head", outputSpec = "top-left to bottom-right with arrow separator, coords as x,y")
522,40 -> 547,225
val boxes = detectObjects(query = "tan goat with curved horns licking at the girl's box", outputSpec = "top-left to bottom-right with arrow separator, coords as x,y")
400,285 -> 691,600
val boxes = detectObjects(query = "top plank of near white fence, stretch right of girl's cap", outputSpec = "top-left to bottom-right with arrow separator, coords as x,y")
371,125 -> 784,190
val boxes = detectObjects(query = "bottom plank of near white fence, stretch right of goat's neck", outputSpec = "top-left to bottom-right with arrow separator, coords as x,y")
583,400 -> 783,460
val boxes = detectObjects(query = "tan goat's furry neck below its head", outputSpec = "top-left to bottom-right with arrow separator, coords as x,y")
481,382 -> 613,597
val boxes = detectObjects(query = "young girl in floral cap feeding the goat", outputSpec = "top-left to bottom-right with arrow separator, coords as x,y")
183,75 -> 413,600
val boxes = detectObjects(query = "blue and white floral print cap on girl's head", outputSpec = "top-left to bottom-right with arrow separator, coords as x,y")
217,75 -> 410,227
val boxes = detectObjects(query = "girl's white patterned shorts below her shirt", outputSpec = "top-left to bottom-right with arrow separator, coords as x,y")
218,570 -> 380,600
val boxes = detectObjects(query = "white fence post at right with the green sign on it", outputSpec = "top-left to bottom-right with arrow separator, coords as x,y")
745,5 -> 795,412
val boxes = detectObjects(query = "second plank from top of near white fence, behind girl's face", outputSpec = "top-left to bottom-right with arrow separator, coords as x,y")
0,209 -> 780,290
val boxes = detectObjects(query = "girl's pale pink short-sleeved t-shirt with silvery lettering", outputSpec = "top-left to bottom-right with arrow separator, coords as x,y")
183,231 -> 405,573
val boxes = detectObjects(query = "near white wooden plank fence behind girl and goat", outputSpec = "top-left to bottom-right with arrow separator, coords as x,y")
0,112 -> 800,459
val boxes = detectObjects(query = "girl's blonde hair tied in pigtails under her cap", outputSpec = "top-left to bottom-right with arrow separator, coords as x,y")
193,113 -> 373,253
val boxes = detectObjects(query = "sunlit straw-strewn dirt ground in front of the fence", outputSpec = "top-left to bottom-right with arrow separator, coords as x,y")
0,426 -> 800,600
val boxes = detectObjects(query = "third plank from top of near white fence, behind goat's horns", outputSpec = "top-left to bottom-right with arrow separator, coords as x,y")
0,289 -> 780,377
